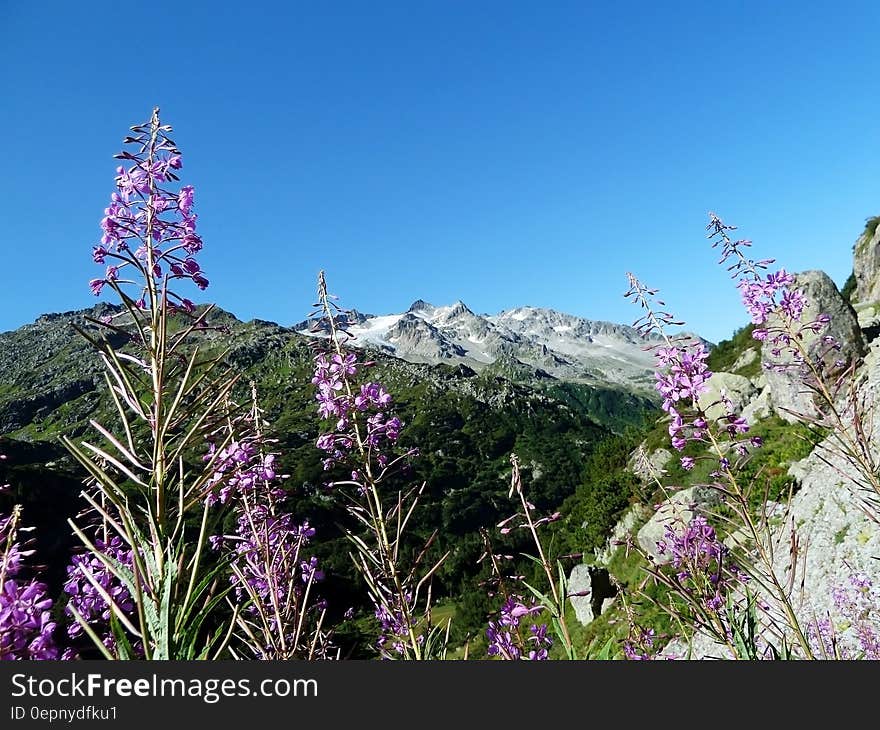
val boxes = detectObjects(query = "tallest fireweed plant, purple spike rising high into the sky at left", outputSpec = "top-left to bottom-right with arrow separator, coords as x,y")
57,109 -> 256,659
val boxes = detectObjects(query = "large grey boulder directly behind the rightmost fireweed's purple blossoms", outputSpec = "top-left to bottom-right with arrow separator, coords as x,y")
761,271 -> 865,423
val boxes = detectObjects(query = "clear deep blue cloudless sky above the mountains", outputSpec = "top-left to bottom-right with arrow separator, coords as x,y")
0,0 -> 880,340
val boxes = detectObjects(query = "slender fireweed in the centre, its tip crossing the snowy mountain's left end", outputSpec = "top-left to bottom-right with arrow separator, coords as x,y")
312,272 -> 450,659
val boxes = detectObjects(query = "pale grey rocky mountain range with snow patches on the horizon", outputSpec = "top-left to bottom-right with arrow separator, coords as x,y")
306,299 -> 696,392
